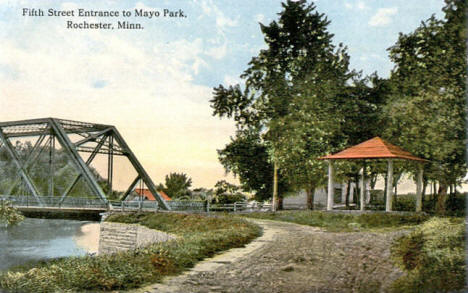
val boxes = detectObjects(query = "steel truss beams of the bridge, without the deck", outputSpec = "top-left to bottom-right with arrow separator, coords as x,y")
0,118 -> 170,210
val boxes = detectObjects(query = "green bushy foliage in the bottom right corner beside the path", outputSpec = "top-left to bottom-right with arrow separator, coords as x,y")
392,218 -> 466,292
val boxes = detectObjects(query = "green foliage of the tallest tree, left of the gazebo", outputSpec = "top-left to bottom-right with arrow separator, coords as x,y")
211,0 -> 358,199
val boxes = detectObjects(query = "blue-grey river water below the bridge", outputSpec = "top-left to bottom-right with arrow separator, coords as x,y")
0,218 -> 99,270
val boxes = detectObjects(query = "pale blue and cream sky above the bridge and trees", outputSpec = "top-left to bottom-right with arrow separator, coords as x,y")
0,0 -> 444,188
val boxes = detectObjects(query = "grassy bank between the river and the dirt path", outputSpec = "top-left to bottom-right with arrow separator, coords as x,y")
0,213 -> 261,292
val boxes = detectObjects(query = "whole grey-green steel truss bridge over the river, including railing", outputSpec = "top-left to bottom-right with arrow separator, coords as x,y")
0,118 -> 171,210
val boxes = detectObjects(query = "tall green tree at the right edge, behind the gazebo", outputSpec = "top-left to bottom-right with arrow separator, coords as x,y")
386,0 -> 467,212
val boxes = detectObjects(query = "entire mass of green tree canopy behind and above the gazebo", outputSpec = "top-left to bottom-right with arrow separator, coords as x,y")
211,0 -> 466,211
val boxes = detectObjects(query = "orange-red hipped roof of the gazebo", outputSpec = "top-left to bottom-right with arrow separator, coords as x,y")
319,137 -> 427,161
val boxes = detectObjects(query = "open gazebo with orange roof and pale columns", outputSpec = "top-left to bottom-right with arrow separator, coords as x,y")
319,137 -> 427,212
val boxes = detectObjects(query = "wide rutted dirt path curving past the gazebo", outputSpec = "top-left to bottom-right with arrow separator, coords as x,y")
135,220 -> 401,293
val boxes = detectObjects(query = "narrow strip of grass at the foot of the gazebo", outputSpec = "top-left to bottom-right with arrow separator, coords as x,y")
242,210 -> 428,232
